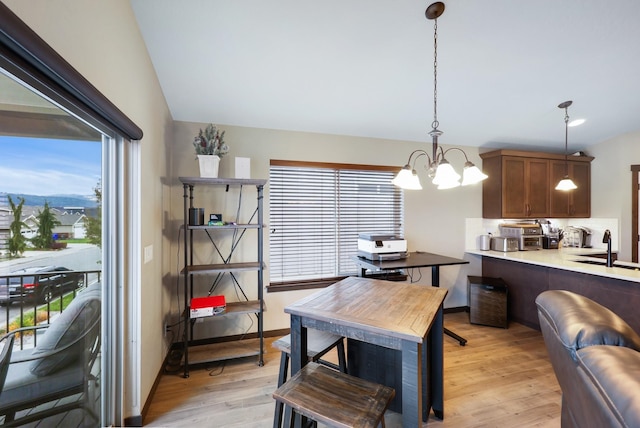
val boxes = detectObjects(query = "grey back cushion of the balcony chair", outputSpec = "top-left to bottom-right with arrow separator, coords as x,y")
29,287 -> 101,376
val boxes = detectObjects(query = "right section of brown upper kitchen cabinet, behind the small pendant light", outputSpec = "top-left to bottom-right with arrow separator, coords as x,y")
550,160 -> 591,218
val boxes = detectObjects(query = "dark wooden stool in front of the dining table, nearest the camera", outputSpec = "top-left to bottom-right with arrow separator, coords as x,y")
273,363 -> 395,428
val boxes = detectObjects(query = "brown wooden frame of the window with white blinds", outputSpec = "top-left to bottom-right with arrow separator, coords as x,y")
266,159 -> 405,292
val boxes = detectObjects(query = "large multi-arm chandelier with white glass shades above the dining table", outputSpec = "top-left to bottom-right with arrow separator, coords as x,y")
391,2 -> 487,189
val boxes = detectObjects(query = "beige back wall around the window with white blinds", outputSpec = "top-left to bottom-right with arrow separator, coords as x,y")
170,122 -> 482,335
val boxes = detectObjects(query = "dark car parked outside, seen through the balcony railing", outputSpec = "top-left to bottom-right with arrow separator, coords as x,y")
0,266 -> 84,305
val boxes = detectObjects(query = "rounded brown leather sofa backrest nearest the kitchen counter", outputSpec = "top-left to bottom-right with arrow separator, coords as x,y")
536,290 -> 640,360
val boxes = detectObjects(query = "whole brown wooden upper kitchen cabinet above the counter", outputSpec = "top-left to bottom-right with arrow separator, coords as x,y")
480,150 -> 593,218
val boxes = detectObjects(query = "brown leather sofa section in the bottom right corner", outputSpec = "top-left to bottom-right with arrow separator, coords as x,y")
576,346 -> 640,427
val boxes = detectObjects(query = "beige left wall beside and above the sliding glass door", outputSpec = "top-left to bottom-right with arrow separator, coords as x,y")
4,0 -> 172,417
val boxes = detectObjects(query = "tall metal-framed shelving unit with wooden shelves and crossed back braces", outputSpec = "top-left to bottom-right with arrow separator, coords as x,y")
180,177 -> 266,378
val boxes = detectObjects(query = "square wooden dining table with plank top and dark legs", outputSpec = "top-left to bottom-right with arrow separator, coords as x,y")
285,277 -> 447,428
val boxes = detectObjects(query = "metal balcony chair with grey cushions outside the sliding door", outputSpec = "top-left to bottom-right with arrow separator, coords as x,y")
0,284 -> 101,426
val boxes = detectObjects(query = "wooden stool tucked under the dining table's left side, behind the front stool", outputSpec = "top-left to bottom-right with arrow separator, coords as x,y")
271,329 -> 347,428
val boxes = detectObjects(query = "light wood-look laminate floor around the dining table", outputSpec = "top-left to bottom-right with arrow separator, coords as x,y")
144,312 -> 561,428
